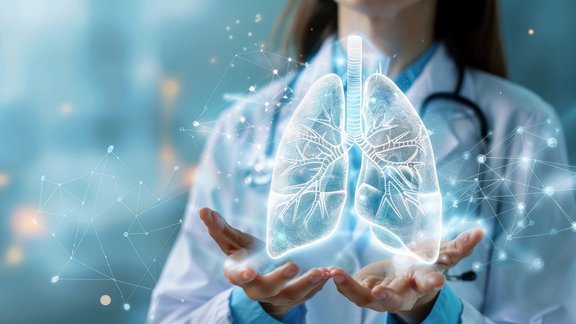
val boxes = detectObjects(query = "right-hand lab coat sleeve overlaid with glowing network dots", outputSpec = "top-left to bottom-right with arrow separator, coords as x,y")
462,102 -> 576,323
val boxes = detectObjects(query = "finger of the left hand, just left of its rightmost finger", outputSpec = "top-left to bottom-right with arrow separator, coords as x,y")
240,262 -> 299,300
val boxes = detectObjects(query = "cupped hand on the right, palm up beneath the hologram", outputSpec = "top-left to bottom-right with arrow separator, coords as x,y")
330,229 -> 484,323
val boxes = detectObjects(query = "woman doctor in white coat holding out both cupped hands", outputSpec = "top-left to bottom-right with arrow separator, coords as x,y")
148,0 -> 576,323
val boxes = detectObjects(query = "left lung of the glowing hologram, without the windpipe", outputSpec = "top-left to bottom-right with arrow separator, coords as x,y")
266,74 -> 348,258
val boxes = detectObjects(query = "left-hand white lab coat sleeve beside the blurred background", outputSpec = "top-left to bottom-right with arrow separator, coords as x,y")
147,114 -> 241,323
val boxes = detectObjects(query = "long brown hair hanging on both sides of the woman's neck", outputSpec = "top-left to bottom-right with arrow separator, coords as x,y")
277,0 -> 506,77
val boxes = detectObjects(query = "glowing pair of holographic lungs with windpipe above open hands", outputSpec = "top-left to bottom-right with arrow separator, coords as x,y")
266,36 -> 442,263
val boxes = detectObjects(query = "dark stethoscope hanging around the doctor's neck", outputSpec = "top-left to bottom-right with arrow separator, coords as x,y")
244,59 -> 490,281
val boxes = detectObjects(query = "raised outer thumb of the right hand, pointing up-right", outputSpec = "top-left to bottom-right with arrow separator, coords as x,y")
436,228 -> 484,270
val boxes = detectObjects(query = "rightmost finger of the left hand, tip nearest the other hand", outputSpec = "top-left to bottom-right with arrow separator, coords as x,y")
279,269 -> 330,301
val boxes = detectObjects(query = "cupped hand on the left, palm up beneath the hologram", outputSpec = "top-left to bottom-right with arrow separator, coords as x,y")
199,208 -> 330,319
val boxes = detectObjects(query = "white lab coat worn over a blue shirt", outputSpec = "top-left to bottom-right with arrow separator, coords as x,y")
148,42 -> 576,323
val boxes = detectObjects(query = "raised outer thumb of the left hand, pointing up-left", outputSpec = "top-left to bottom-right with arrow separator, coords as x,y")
198,208 -> 259,255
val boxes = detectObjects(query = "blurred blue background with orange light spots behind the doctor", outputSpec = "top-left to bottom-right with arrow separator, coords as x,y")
0,0 -> 576,323
